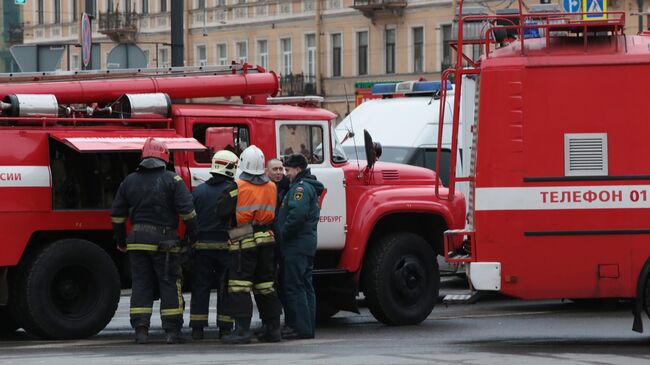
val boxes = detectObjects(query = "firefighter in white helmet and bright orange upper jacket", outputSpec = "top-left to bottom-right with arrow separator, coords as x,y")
222,145 -> 282,344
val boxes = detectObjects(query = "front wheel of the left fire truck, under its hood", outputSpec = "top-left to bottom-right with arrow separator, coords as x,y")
362,232 -> 440,326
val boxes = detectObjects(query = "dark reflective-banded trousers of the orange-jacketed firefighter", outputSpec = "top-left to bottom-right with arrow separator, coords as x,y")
227,242 -> 282,322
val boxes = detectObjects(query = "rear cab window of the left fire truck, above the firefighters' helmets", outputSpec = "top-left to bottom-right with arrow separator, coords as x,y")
192,123 -> 250,164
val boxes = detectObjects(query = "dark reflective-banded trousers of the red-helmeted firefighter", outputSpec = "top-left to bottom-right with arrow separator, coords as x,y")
129,250 -> 185,331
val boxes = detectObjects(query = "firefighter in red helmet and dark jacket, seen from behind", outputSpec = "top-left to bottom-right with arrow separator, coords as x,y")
111,138 -> 198,344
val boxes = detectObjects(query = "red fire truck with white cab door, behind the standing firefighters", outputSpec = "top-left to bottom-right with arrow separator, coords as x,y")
0,65 -> 465,338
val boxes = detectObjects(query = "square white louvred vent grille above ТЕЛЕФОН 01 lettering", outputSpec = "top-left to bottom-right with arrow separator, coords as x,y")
564,133 -> 608,176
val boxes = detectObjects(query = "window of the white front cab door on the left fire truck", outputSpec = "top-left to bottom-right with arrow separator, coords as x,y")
279,124 -> 324,164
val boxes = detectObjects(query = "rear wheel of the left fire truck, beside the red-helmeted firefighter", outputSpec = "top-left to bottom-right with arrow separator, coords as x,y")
25,239 -> 120,339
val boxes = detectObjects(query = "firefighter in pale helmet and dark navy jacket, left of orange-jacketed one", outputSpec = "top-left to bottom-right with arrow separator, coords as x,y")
190,150 -> 239,340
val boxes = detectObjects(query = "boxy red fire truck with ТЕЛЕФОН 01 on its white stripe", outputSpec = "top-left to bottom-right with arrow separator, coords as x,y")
438,1 -> 650,331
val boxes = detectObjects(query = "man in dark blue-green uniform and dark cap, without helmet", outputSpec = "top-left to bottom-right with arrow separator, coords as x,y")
278,154 -> 324,339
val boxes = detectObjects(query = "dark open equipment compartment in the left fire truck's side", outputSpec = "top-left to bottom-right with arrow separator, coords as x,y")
50,138 -> 142,210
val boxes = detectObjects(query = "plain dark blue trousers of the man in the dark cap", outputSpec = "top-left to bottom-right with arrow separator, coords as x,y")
282,252 -> 316,336
